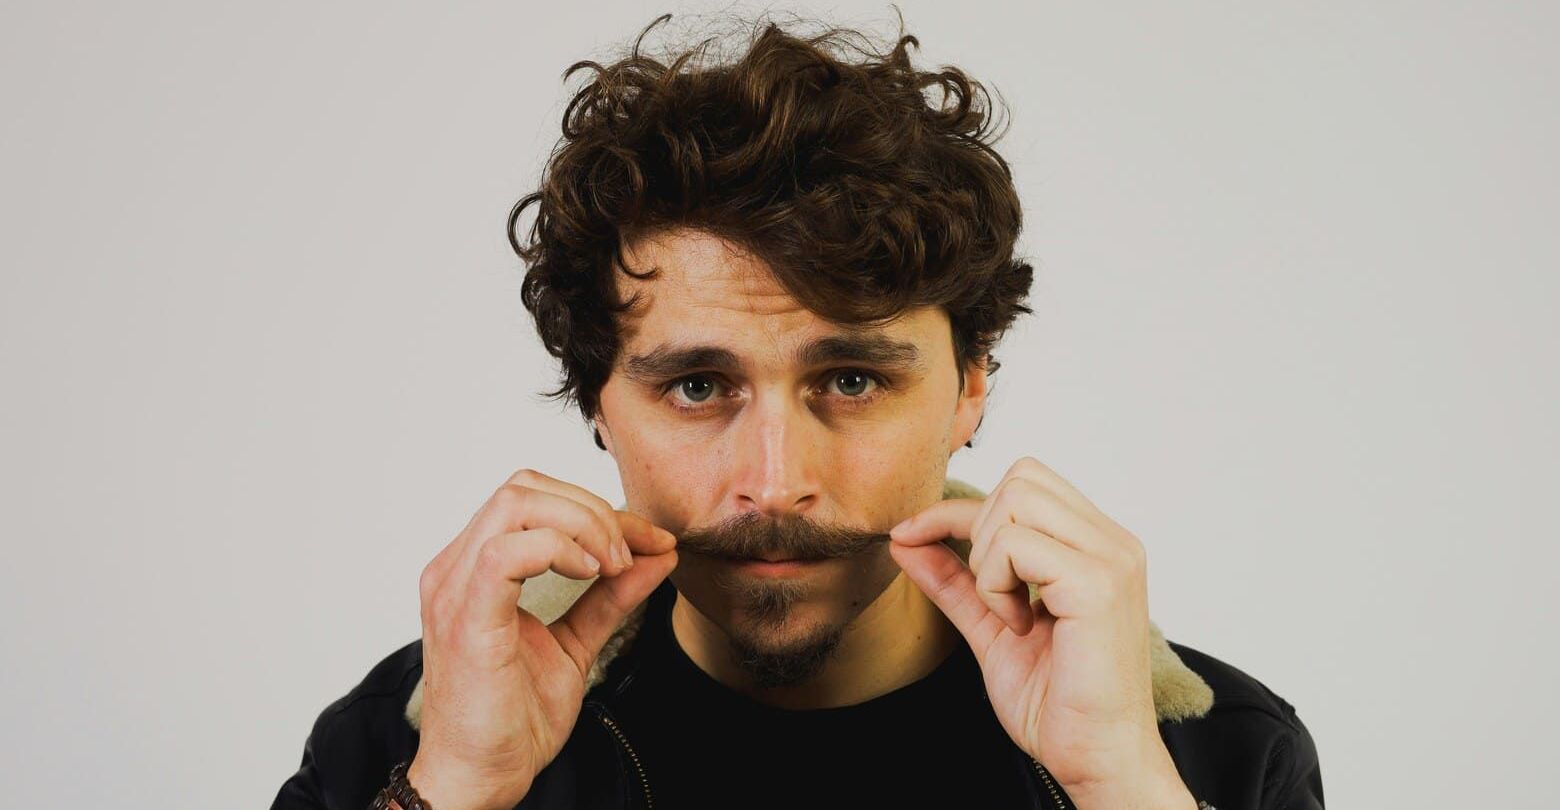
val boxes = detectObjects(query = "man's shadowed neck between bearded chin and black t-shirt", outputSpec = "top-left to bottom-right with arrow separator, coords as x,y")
672,573 -> 958,709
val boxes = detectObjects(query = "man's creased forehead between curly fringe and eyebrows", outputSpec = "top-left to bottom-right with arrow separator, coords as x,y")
615,229 -> 948,362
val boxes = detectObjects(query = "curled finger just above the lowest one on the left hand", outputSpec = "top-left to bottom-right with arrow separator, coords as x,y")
451,484 -> 624,588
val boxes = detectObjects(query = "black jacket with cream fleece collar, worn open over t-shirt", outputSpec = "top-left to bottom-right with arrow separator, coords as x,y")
271,479 -> 1323,810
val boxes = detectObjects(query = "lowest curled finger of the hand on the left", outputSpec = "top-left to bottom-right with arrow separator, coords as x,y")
465,526 -> 599,631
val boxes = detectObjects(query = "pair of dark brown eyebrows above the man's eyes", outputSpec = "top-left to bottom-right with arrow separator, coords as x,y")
624,334 -> 924,382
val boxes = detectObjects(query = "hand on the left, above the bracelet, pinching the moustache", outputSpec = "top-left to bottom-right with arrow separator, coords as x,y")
407,470 -> 677,810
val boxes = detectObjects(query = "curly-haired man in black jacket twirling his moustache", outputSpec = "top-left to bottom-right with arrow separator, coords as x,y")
273,17 -> 1321,810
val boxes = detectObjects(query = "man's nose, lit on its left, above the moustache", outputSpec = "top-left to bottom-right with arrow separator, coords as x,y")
732,398 -> 825,517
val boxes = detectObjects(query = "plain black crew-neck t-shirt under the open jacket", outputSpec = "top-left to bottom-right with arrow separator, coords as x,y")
605,581 -> 1033,808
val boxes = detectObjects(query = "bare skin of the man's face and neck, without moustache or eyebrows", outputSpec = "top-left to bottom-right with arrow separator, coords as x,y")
596,229 -> 986,709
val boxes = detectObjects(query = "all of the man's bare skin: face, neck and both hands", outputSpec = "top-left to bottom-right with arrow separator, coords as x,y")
409,224 -> 1195,810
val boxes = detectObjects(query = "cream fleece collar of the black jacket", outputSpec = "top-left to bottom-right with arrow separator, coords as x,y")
404,478 -> 1214,729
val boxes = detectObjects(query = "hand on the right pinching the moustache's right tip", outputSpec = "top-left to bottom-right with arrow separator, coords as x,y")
889,457 -> 1195,807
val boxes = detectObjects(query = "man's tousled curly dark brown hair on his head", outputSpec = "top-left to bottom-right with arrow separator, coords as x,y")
507,14 -> 1033,446
